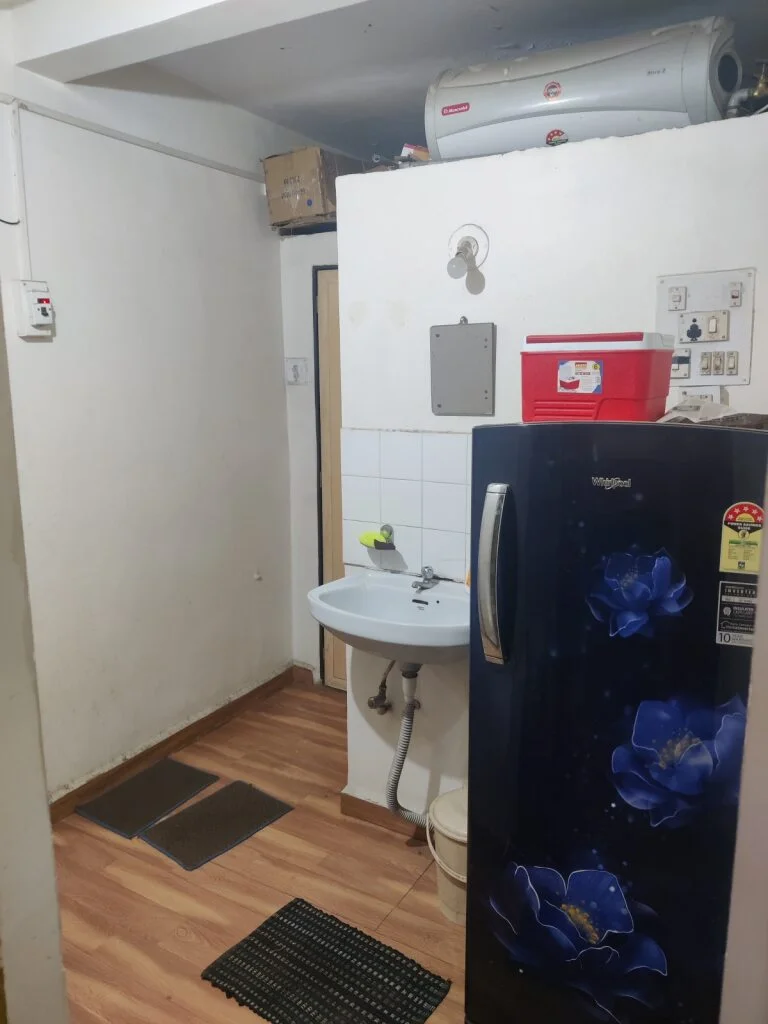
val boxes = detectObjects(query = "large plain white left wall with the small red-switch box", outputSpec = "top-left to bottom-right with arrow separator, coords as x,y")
0,112 -> 291,795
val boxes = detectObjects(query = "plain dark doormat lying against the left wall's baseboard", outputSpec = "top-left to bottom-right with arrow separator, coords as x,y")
77,758 -> 218,839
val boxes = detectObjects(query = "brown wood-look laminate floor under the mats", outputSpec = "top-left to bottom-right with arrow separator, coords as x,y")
54,684 -> 464,1024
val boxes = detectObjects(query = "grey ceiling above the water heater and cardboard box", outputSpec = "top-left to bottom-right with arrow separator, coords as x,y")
153,0 -> 768,157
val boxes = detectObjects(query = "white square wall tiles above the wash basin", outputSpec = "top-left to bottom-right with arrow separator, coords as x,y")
341,429 -> 471,581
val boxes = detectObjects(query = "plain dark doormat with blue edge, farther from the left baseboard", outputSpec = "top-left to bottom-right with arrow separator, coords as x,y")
141,782 -> 293,871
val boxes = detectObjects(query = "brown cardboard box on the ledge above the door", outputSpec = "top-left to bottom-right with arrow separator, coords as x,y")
263,145 -> 366,227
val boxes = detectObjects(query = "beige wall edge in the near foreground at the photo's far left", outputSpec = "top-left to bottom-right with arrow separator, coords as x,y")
0,294 -> 67,1024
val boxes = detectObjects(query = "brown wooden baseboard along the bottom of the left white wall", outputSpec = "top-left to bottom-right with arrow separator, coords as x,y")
49,666 -> 303,823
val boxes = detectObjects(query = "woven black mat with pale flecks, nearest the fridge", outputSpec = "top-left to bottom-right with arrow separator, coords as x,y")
202,899 -> 451,1024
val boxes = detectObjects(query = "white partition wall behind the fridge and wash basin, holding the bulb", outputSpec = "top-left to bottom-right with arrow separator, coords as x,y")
338,112 -> 768,810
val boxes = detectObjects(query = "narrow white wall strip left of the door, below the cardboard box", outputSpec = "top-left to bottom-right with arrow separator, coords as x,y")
280,231 -> 337,678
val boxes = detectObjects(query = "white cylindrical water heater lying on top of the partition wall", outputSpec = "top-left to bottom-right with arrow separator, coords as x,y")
426,17 -> 741,160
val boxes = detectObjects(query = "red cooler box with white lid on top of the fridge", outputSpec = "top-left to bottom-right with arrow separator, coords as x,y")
522,332 -> 675,423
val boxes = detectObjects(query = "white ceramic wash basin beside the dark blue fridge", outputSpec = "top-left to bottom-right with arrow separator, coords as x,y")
308,572 -> 469,665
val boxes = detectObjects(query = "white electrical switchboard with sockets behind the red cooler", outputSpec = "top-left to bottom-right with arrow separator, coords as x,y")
656,267 -> 755,391
